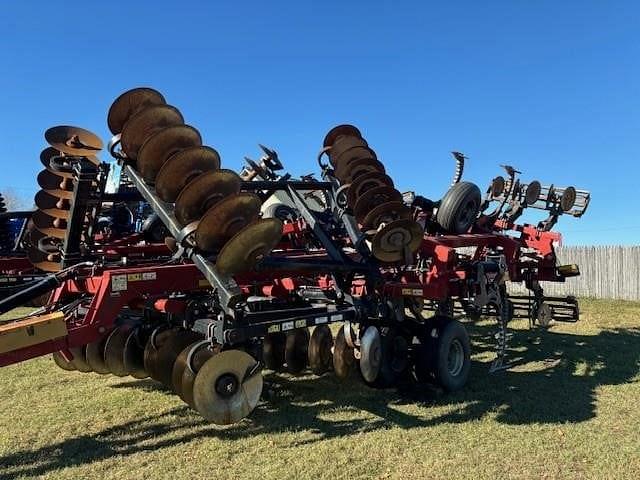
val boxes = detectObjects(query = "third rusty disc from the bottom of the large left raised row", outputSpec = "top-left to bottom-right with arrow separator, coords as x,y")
175,169 -> 242,225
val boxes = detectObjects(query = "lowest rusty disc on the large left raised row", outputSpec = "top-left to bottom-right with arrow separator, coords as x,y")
216,218 -> 282,275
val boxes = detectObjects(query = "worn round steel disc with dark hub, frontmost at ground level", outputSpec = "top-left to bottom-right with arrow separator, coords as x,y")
193,350 -> 263,425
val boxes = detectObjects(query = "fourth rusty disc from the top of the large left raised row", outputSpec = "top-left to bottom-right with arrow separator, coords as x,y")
155,146 -> 220,203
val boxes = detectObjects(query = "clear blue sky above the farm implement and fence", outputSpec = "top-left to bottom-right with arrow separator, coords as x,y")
0,0 -> 640,244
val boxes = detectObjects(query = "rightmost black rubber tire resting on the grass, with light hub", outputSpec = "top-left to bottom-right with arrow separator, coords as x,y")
433,320 -> 471,392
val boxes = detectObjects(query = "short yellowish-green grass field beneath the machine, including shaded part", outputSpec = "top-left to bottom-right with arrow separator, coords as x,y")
0,301 -> 640,480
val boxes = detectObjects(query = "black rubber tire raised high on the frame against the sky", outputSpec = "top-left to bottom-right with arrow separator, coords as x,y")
436,182 -> 482,234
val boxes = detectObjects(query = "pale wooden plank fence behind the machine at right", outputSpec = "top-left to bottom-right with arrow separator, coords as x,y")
510,246 -> 640,300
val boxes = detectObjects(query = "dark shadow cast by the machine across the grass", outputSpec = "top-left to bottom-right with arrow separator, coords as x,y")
0,326 -> 640,480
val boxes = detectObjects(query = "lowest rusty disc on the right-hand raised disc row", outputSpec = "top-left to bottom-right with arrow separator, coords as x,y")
371,218 -> 424,263
